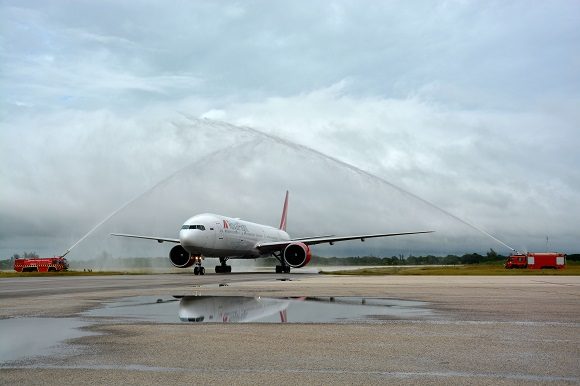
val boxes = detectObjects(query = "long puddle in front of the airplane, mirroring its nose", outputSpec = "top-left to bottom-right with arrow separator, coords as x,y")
83,296 -> 438,323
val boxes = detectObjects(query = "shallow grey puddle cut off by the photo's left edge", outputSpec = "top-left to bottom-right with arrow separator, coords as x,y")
0,318 -> 94,362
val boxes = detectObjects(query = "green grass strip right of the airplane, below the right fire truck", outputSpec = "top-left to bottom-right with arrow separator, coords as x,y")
320,263 -> 580,276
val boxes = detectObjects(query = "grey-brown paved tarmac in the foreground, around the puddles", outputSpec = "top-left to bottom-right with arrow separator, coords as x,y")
0,273 -> 580,385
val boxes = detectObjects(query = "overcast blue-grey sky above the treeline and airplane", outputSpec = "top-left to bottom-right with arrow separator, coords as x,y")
0,0 -> 580,257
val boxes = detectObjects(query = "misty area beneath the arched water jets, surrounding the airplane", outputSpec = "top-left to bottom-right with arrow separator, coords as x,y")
66,114 -> 513,256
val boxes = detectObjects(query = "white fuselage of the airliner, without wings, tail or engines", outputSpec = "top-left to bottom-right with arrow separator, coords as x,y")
179,213 -> 290,258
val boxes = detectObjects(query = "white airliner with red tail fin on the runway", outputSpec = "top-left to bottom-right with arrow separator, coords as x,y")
111,191 -> 434,275
